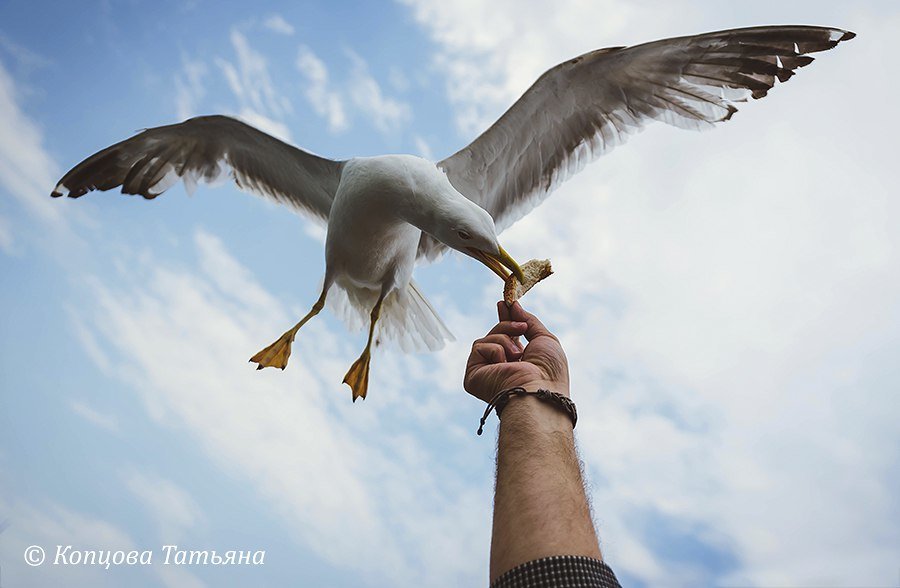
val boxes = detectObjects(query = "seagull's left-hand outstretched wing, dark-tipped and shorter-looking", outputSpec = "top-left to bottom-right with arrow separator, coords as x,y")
51,116 -> 344,221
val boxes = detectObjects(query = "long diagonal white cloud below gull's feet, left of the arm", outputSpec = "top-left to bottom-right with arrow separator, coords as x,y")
79,227 -> 490,586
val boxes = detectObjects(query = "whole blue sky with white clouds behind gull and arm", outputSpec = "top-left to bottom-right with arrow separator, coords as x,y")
0,0 -> 900,588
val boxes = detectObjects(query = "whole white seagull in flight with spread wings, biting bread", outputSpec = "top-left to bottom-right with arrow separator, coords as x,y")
51,26 -> 855,402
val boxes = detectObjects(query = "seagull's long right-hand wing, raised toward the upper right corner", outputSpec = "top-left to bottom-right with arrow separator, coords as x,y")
419,26 -> 855,259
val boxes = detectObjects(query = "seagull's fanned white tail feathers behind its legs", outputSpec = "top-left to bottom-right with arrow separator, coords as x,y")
328,281 -> 455,352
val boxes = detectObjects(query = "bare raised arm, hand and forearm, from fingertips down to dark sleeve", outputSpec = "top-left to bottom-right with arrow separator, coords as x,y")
465,302 -> 601,582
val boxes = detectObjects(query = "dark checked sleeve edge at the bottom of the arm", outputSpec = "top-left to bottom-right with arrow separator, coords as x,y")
490,555 -> 621,588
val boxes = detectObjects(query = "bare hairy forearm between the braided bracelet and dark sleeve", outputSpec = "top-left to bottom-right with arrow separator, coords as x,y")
490,396 -> 600,581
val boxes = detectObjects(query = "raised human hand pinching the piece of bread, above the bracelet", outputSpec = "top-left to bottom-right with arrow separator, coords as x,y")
463,301 -> 569,402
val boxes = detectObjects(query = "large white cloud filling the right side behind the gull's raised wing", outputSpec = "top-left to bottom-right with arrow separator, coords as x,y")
409,0 -> 900,585
